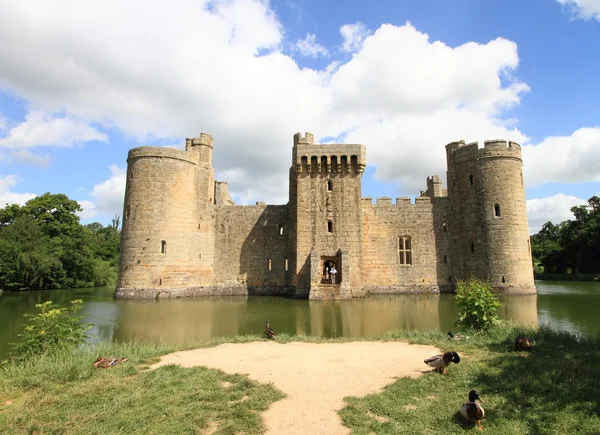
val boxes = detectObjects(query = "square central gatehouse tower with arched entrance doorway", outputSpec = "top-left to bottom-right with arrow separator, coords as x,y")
290,133 -> 366,298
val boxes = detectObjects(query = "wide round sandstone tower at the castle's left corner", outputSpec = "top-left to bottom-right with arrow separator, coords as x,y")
115,134 -> 214,298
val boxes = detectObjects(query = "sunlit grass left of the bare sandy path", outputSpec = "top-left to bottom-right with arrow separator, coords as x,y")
0,344 -> 284,434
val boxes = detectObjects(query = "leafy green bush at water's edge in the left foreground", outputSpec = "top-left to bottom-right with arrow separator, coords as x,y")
13,299 -> 93,361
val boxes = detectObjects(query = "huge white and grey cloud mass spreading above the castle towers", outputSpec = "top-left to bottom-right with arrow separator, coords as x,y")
0,0 -> 529,201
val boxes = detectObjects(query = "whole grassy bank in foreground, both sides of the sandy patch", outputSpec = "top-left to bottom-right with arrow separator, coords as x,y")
0,327 -> 600,434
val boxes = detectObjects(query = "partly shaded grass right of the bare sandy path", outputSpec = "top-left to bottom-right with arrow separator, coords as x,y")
339,327 -> 600,435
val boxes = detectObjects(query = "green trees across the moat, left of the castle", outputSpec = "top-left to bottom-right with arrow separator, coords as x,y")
0,193 -> 121,291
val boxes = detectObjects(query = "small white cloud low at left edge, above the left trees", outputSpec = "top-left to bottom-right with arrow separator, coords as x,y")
0,110 -> 107,148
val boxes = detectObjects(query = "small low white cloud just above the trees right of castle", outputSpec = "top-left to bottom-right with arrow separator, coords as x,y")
527,193 -> 587,234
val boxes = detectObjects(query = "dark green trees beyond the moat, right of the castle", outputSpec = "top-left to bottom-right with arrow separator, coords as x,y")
531,196 -> 600,274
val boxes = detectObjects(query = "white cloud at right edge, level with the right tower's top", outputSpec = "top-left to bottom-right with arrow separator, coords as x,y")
522,127 -> 600,186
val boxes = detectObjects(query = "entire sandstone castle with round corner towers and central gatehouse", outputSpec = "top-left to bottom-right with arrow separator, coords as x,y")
116,133 -> 536,299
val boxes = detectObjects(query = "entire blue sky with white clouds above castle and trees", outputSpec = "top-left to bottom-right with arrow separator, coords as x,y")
0,0 -> 600,232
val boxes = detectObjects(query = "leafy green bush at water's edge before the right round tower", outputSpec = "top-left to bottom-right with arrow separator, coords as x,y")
456,278 -> 500,331
